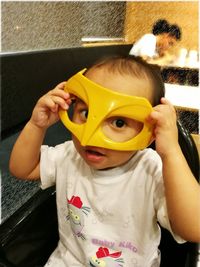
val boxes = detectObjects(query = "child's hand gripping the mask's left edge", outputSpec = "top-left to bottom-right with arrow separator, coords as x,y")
30,82 -> 71,128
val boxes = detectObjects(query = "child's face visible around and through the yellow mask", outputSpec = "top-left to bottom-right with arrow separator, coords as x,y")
73,69 -> 152,169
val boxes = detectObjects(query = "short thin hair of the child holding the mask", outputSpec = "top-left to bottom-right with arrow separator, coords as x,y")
86,55 -> 165,106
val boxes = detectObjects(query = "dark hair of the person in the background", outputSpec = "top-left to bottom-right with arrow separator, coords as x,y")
152,19 -> 181,40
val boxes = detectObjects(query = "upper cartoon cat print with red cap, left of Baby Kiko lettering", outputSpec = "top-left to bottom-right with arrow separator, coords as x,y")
67,196 -> 90,240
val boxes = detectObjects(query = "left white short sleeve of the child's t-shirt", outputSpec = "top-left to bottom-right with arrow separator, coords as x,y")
40,145 -> 56,189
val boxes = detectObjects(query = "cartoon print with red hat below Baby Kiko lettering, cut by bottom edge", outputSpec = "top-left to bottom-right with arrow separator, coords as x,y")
88,247 -> 124,267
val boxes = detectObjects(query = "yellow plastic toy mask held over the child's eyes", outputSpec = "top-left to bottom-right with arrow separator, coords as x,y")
59,69 -> 153,151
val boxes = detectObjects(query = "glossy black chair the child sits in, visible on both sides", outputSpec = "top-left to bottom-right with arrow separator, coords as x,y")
0,122 -> 199,267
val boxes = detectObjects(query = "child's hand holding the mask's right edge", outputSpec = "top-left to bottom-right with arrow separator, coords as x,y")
147,97 -> 179,158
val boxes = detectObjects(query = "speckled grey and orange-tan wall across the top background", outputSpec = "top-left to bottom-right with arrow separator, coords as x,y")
1,1 -> 199,56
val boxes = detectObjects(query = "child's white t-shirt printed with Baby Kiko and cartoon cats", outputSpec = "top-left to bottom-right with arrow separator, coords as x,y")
41,141 -> 184,267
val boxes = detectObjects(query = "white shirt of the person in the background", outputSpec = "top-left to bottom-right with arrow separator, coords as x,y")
129,33 -> 158,58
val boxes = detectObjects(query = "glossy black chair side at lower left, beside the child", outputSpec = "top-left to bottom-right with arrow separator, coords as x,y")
0,188 -> 59,267
